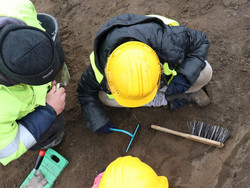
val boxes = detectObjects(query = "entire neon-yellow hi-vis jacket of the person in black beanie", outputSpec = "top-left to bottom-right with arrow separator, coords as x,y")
0,0 -> 47,165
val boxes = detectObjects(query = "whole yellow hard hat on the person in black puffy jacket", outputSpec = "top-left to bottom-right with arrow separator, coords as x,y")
105,41 -> 161,107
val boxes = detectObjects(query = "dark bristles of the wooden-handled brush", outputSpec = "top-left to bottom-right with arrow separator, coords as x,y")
188,121 -> 230,143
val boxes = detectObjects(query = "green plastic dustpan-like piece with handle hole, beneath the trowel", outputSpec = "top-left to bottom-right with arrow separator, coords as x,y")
20,148 -> 69,188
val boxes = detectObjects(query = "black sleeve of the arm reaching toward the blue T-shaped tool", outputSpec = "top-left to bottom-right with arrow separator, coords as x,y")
77,66 -> 109,132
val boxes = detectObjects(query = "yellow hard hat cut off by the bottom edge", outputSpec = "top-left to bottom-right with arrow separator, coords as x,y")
99,156 -> 168,188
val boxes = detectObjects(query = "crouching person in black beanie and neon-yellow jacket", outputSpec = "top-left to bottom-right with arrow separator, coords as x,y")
0,0 -> 66,165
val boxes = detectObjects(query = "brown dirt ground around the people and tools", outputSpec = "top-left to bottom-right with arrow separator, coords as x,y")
0,0 -> 250,188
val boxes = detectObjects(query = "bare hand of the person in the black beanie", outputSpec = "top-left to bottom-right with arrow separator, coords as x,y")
46,85 -> 66,115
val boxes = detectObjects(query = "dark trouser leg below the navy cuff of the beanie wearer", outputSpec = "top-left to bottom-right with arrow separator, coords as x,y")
30,113 -> 65,150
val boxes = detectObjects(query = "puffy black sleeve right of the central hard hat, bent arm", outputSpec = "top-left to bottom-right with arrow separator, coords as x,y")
150,26 -> 209,84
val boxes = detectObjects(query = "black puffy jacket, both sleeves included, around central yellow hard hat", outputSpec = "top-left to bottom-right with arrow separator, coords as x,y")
77,14 -> 209,132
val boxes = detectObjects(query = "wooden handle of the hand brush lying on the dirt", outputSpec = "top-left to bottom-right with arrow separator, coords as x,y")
151,125 -> 224,148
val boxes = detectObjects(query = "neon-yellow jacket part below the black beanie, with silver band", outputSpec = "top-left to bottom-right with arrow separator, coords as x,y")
0,84 -> 49,165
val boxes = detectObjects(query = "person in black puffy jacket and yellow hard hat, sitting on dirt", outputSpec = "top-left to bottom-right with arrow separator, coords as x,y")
77,14 -> 212,133
